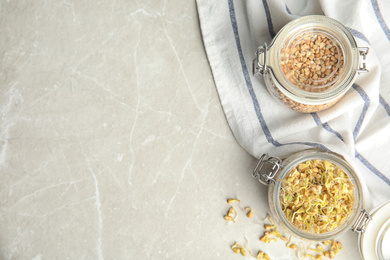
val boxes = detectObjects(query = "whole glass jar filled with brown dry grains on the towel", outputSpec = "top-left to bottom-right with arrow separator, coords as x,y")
253,15 -> 368,113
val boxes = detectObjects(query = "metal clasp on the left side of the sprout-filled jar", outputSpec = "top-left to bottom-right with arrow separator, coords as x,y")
252,154 -> 282,185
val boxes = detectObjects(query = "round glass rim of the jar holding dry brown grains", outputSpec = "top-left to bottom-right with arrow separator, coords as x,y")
268,15 -> 359,105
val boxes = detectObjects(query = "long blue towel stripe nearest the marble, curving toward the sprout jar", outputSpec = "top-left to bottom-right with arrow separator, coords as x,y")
228,0 -> 329,151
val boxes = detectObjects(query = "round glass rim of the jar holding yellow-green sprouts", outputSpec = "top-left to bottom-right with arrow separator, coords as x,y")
268,149 -> 363,241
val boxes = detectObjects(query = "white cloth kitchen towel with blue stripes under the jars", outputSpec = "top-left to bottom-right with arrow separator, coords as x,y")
197,0 -> 390,209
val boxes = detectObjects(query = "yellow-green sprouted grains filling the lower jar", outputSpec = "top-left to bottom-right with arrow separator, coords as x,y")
280,159 -> 355,234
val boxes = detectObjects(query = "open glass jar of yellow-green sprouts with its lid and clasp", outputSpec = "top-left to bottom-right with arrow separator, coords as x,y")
253,149 -> 390,259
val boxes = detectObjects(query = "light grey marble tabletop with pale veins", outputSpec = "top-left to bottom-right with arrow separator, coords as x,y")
0,0 -> 359,260
